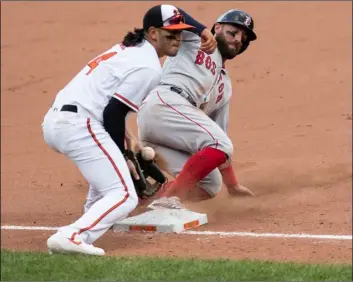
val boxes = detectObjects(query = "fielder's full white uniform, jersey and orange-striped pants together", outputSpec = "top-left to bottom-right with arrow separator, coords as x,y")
42,41 -> 162,249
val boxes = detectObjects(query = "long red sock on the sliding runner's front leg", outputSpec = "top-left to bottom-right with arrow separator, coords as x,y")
173,147 -> 227,190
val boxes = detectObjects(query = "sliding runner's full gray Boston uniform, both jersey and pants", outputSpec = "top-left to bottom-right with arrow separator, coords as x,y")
137,31 -> 233,196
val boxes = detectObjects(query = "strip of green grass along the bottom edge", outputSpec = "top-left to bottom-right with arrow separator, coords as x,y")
1,249 -> 352,281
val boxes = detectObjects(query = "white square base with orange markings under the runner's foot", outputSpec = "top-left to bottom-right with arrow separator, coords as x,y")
113,209 -> 208,233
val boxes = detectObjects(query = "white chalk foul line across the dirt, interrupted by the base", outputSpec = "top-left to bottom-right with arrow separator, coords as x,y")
1,225 -> 352,240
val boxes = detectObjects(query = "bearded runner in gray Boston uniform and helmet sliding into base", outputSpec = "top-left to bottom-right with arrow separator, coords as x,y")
137,10 -> 256,207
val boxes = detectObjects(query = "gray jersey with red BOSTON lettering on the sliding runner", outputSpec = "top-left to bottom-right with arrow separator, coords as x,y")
161,31 -> 232,131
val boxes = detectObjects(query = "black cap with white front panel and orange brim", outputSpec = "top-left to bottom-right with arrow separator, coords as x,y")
143,5 -> 194,31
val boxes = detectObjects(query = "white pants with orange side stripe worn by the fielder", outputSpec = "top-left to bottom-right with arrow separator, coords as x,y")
42,107 -> 138,244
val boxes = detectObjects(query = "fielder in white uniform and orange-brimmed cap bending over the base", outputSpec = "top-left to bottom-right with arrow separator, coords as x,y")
42,5 -> 216,255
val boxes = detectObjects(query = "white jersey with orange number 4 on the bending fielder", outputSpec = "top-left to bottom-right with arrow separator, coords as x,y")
55,41 -> 162,122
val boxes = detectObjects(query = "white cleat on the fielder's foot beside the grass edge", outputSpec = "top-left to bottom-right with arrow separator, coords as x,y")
47,232 -> 105,256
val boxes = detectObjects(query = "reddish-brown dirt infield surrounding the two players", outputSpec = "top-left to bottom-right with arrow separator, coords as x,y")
1,1 -> 352,263
